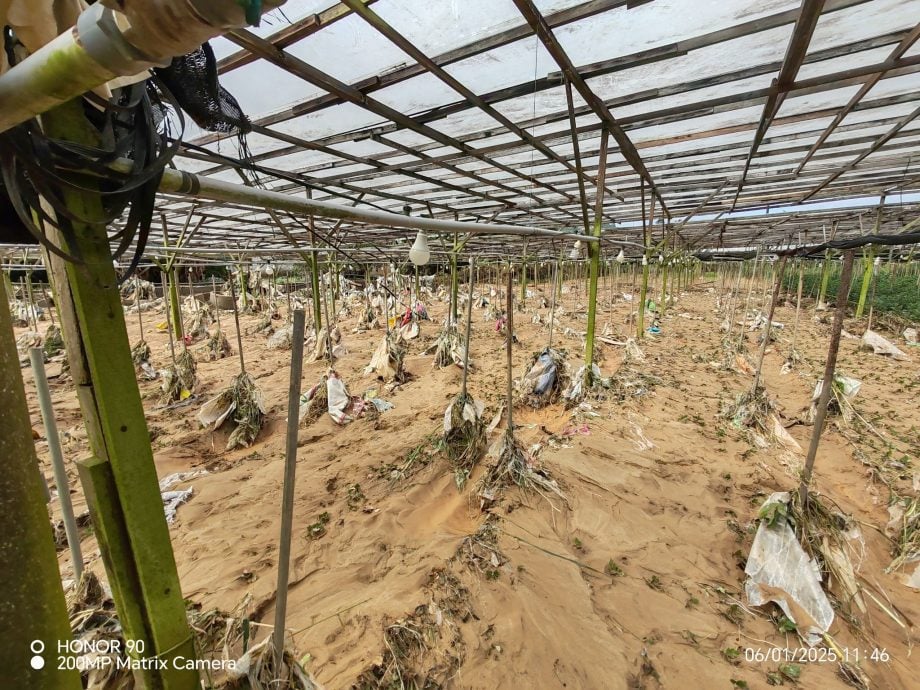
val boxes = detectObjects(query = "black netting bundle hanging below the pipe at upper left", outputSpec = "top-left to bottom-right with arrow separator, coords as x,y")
155,43 -> 251,134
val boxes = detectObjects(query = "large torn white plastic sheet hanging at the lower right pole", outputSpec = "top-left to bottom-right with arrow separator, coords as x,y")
744,491 -> 834,646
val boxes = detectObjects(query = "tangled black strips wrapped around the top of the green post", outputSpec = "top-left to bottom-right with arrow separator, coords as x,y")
0,71 -> 184,281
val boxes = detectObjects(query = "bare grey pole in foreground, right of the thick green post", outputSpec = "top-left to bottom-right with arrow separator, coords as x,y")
272,309 -> 306,678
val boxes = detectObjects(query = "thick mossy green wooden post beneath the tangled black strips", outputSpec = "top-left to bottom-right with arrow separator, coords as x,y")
42,102 -> 199,690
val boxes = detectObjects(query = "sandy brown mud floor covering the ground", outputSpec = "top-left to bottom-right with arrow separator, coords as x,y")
17,282 -> 920,690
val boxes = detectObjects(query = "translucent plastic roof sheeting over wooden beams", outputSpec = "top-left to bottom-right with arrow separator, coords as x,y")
161,0 -> 920,255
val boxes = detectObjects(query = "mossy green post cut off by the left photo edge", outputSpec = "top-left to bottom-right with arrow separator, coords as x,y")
0,280 -> 82,690
